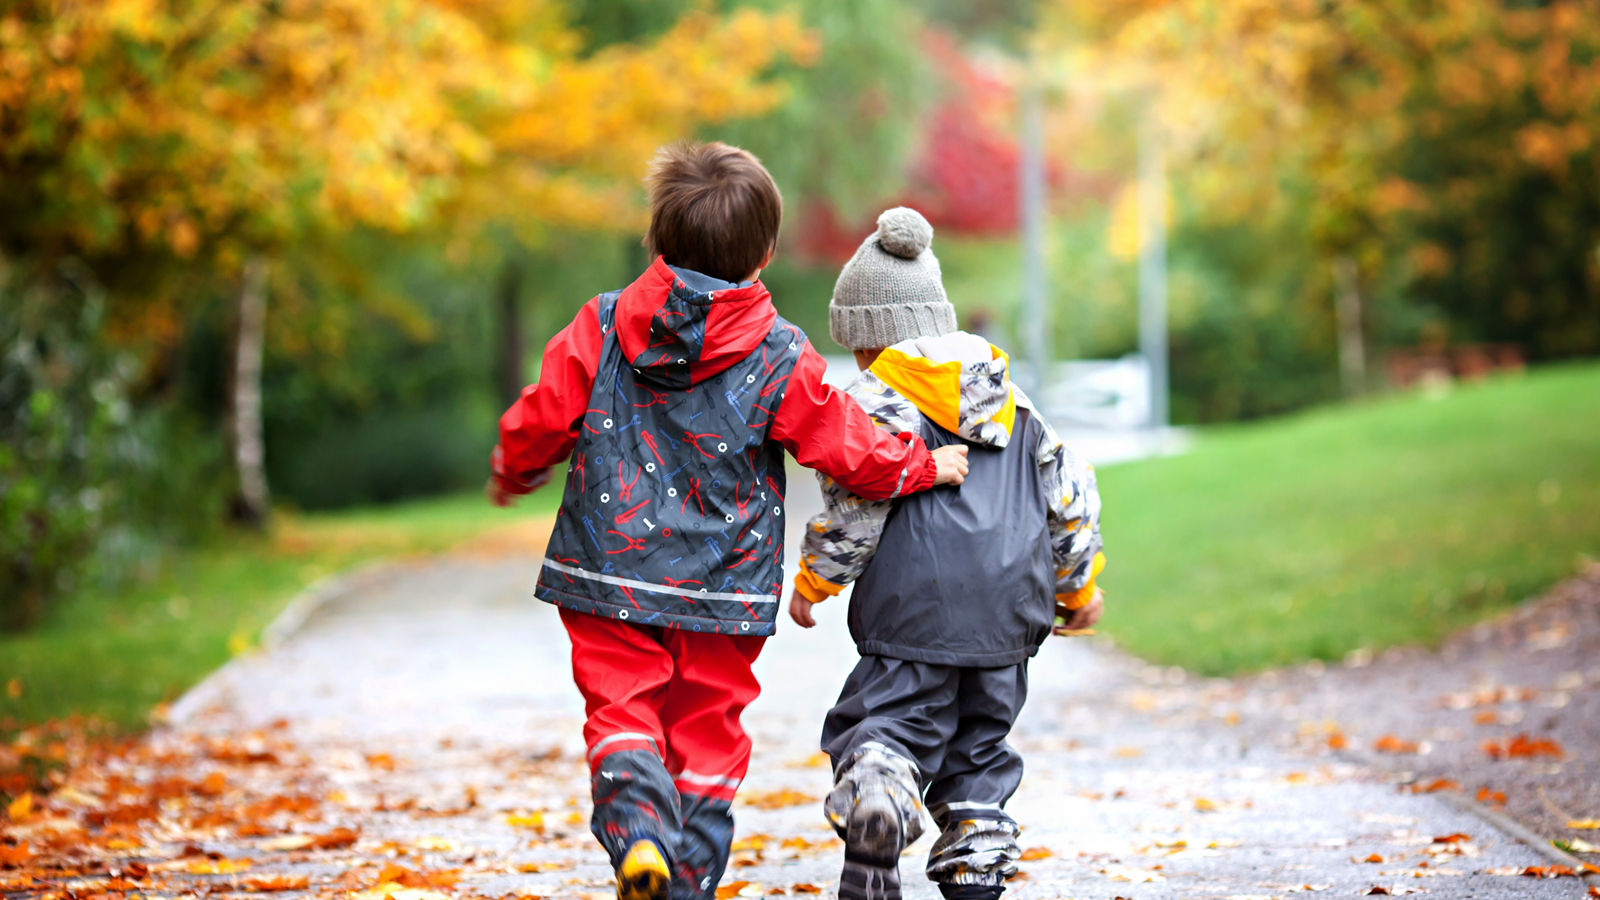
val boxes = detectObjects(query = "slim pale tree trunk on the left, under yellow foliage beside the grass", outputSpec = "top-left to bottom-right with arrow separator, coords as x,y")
230,256 -> 272,528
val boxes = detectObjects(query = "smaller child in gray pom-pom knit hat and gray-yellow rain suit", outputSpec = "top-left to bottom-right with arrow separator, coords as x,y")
789,207 -> 1104,900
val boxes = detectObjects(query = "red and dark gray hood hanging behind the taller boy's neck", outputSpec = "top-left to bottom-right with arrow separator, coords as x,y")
616,256 -> 778,389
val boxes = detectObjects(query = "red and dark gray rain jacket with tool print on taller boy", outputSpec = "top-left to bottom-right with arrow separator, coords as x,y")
493,258 -> 934,636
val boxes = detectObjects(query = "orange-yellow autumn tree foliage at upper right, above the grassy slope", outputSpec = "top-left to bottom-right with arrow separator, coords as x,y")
1045,0 -> 1600,377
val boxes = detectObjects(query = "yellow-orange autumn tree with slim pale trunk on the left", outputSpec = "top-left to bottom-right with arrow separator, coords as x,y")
0,0 -> 811,520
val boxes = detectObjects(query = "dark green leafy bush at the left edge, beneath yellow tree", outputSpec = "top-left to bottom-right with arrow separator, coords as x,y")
0,266 -> 227,628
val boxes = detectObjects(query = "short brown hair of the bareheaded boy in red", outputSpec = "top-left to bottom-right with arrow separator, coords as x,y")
645,141 -> 784,282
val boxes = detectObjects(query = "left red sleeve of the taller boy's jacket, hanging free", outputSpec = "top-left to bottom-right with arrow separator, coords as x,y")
490,298 -> 603,493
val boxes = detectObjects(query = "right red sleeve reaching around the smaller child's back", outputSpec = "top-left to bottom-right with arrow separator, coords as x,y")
770,341 -> 938,500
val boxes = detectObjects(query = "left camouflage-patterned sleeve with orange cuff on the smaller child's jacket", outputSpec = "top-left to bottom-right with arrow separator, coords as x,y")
795,372 -> 922,604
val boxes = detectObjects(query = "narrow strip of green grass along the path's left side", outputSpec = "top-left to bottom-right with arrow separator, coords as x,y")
0,479 -> 560,730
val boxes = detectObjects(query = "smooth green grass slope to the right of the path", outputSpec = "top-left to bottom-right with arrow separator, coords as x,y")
1099,364 -> 1600,674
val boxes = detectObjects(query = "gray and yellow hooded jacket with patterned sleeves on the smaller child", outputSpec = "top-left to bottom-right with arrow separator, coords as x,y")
795,331 -> 1106,666
